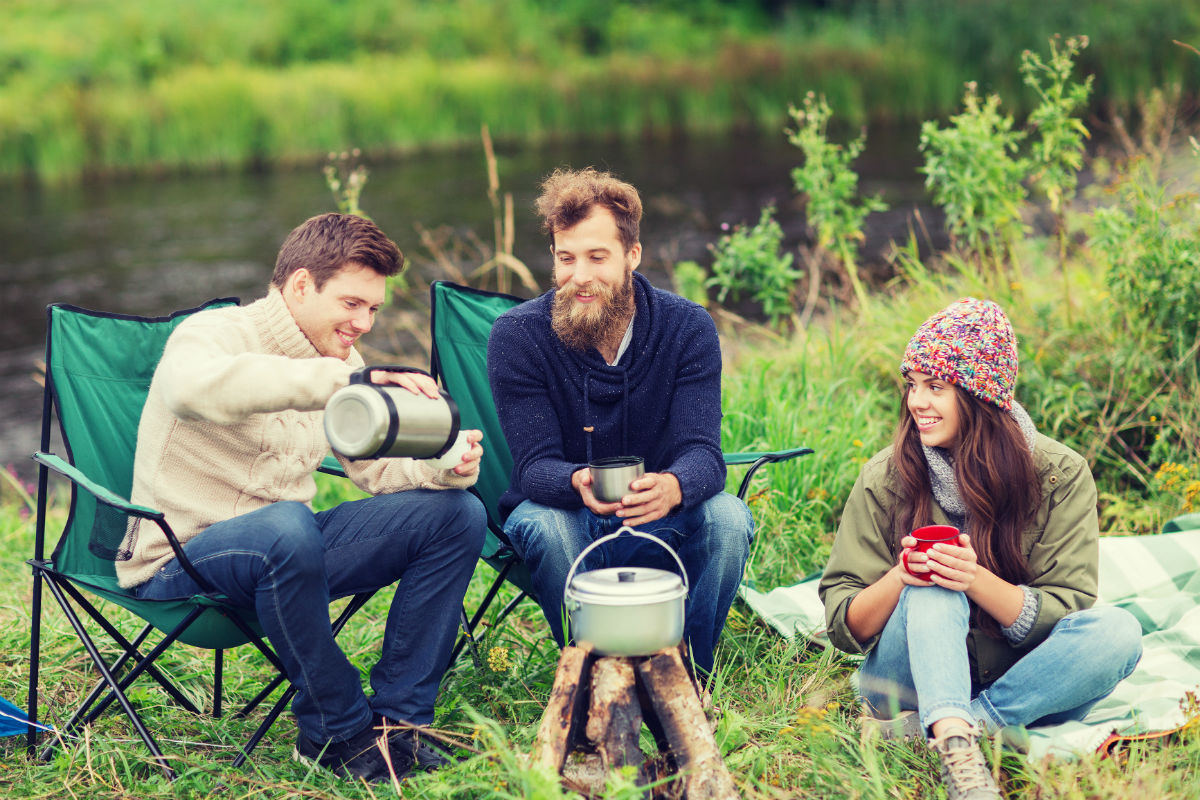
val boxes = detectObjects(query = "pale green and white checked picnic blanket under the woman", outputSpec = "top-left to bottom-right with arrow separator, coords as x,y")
740,515 -> 1200,759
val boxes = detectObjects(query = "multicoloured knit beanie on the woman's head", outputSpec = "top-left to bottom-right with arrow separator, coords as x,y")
900,297 -> 1016,411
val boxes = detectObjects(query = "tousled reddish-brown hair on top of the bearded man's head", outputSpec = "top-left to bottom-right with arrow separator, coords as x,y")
534,167 -> 642,253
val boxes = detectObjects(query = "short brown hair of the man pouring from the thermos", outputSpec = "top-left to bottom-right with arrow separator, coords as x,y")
271,213 -> 404,291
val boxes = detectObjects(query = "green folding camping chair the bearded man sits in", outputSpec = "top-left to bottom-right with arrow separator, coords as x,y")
430,281 -> 812,663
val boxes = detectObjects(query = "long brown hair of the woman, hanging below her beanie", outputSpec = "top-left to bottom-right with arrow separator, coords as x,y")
892,386 -> 1042,597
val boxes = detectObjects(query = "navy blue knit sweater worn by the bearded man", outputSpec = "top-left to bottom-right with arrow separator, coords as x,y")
487,272 -> 725,518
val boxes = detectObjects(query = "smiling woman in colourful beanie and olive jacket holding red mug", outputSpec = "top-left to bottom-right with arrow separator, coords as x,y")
820,297 -> 1141,800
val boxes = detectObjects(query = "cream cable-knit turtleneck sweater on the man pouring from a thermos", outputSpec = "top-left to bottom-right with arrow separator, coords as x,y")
116,288 -> 475,587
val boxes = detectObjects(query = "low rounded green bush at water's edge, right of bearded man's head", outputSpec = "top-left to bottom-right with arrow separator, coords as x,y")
707,206 -> 802,327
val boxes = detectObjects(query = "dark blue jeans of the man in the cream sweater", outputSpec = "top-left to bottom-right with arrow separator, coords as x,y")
137,489 -> 486,741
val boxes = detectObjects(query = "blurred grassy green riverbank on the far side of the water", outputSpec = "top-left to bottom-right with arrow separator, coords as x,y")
0,0 -> 1200,182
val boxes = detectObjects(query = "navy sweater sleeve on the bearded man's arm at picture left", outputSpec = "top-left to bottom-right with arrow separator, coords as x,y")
487,315 -> 587,509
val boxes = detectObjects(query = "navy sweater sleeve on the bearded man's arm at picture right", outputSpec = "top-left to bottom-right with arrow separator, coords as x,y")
665,308 -> 725,510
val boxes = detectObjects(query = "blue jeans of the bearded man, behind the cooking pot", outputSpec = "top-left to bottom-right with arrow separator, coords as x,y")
504,492 -> 754,672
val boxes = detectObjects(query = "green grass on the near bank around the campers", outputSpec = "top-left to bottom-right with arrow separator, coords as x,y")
0,242 -> 1200,800
